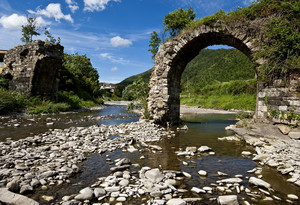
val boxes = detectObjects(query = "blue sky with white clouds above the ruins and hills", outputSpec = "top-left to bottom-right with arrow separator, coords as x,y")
0,0 -> 253,83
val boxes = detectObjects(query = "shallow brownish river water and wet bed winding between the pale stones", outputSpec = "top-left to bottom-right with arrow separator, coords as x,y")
0,105 -> 300,204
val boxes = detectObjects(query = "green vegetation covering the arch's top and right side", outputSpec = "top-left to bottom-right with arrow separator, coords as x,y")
185,0 -> 300,82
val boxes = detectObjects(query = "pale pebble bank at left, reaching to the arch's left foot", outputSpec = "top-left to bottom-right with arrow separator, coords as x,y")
0,121 -> 172,204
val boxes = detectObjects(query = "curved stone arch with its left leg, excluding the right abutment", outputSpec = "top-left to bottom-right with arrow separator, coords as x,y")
148,25 -> 259,125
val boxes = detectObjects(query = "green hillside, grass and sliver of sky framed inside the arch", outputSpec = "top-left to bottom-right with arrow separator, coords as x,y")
180,45 -> 257,98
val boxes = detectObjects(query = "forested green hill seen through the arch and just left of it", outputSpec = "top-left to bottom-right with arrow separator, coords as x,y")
118,49 -> 255,92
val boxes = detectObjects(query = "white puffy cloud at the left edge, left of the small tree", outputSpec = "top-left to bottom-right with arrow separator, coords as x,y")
0,14 -> 26,30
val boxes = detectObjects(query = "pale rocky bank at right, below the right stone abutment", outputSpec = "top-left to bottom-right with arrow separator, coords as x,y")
225,120 -> 300,203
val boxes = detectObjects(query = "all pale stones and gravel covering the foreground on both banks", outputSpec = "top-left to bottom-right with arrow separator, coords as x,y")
0,103 -> 300,205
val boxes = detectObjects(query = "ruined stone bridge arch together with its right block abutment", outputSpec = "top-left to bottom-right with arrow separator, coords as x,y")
148,19 -> 300,125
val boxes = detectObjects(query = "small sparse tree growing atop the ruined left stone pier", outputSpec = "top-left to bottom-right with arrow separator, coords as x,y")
21,17 -> 41,43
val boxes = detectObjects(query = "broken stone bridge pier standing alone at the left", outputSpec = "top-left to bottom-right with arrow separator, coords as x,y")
2,40 -> 64,99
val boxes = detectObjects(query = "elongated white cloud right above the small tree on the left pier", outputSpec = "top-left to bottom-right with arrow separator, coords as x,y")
28,3 -> 74,23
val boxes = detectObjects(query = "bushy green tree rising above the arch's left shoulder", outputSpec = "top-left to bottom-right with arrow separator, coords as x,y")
163,7 -> 196,37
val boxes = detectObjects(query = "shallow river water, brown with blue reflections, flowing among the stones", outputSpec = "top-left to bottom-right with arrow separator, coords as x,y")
0,105 -> 300,204
